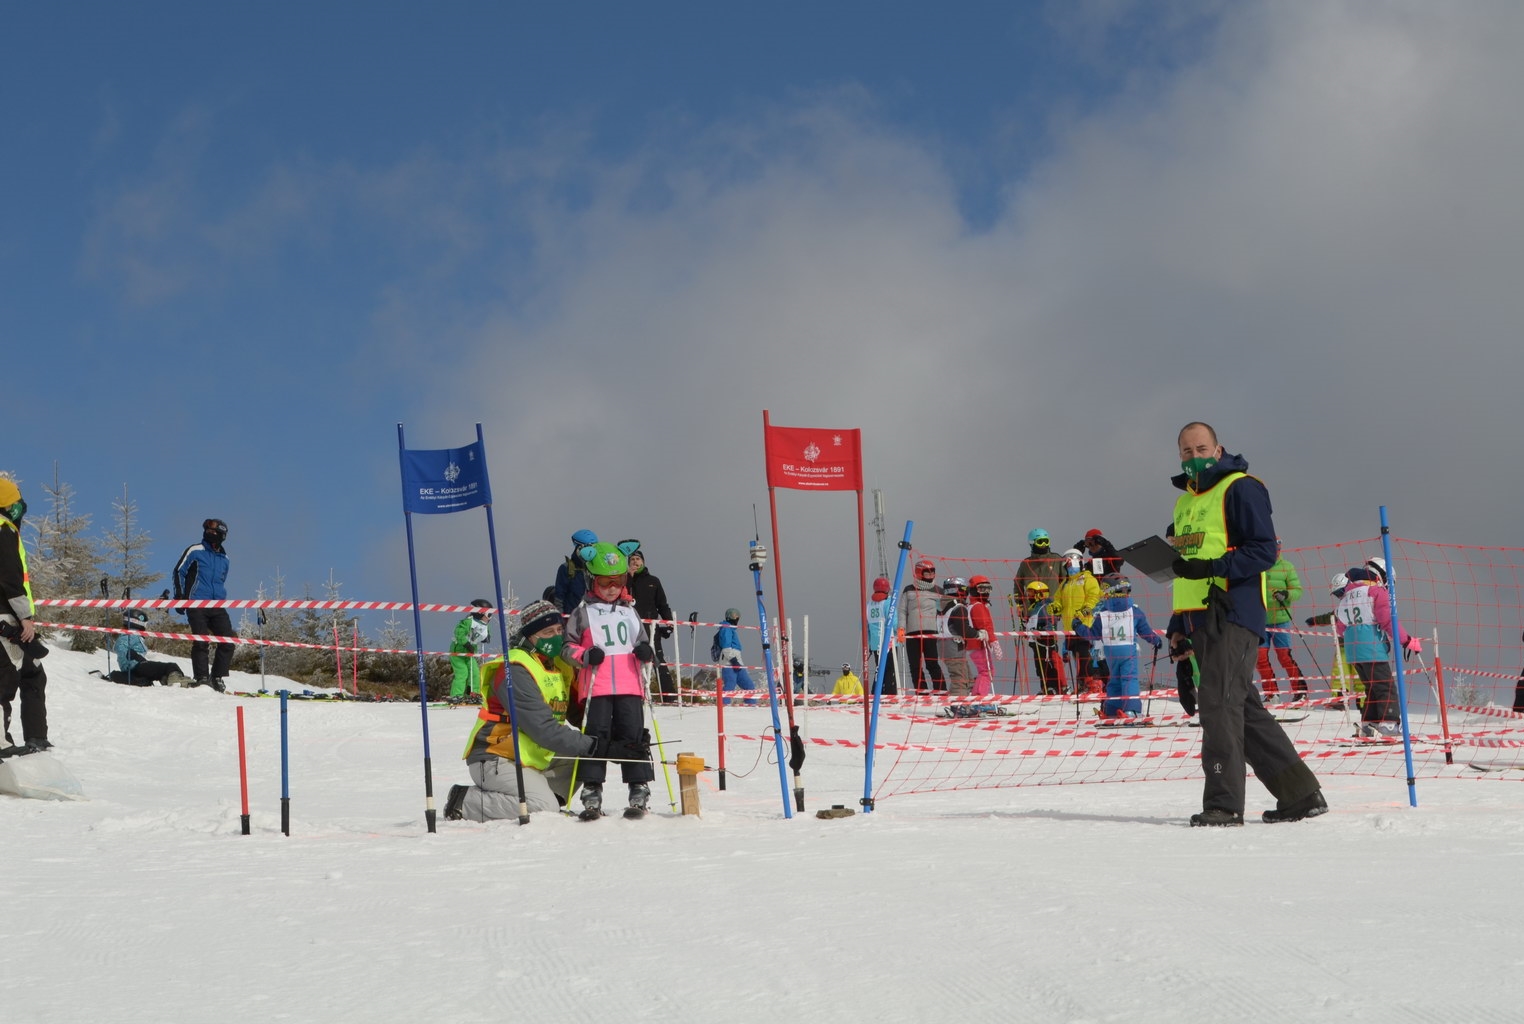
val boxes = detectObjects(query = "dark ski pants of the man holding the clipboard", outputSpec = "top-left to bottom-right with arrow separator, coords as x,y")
1190,587 -> 1318,814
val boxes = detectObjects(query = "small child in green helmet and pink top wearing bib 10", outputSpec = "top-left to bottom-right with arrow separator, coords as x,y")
562,542 -> 655,821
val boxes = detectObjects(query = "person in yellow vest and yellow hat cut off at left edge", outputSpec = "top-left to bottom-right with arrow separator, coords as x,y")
0,477 -> 52,757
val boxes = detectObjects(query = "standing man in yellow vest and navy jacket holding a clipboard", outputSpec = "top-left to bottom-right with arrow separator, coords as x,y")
1167,422 -> 1329,826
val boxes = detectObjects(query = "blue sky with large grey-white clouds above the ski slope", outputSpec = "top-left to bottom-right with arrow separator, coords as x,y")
0,0 -> 1524,661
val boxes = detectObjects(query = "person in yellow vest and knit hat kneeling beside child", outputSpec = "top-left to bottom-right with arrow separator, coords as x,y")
445,600 -> 618,821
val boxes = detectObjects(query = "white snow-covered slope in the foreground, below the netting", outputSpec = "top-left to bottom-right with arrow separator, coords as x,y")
0,651 -> 1524,1024
